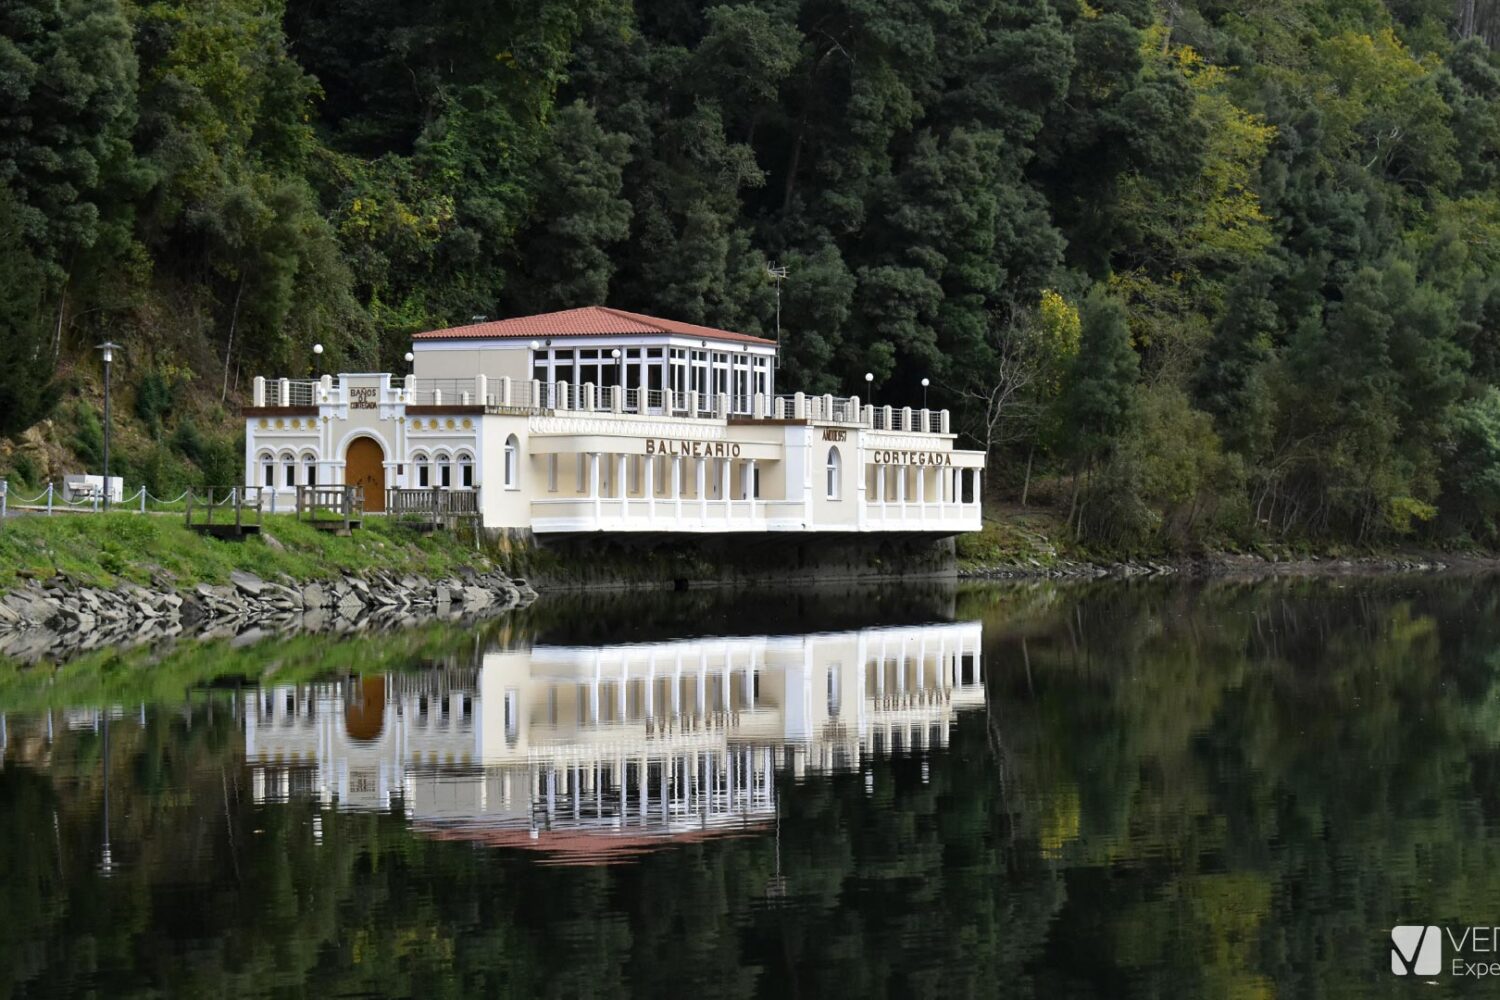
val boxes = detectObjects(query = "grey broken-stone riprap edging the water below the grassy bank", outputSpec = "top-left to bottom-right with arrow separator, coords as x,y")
0,570 -> 537,663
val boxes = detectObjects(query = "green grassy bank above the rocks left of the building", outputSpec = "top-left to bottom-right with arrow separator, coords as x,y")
0,513 -> 495,592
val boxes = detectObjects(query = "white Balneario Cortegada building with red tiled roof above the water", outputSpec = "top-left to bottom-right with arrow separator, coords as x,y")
243,306 -> 984,537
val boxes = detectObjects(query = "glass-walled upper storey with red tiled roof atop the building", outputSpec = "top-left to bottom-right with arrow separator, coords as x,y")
413,306 -> 777,414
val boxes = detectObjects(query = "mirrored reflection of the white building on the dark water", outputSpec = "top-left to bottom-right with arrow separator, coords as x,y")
245,622 -> 984,862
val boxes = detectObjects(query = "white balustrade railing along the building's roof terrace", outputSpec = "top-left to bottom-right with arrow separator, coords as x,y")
254,375 -> 950,435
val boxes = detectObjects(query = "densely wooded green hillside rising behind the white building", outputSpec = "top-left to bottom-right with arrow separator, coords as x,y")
0,0 -> 1500,547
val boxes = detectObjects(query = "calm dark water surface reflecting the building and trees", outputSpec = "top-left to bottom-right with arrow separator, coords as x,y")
0,579 -> 1500,999
